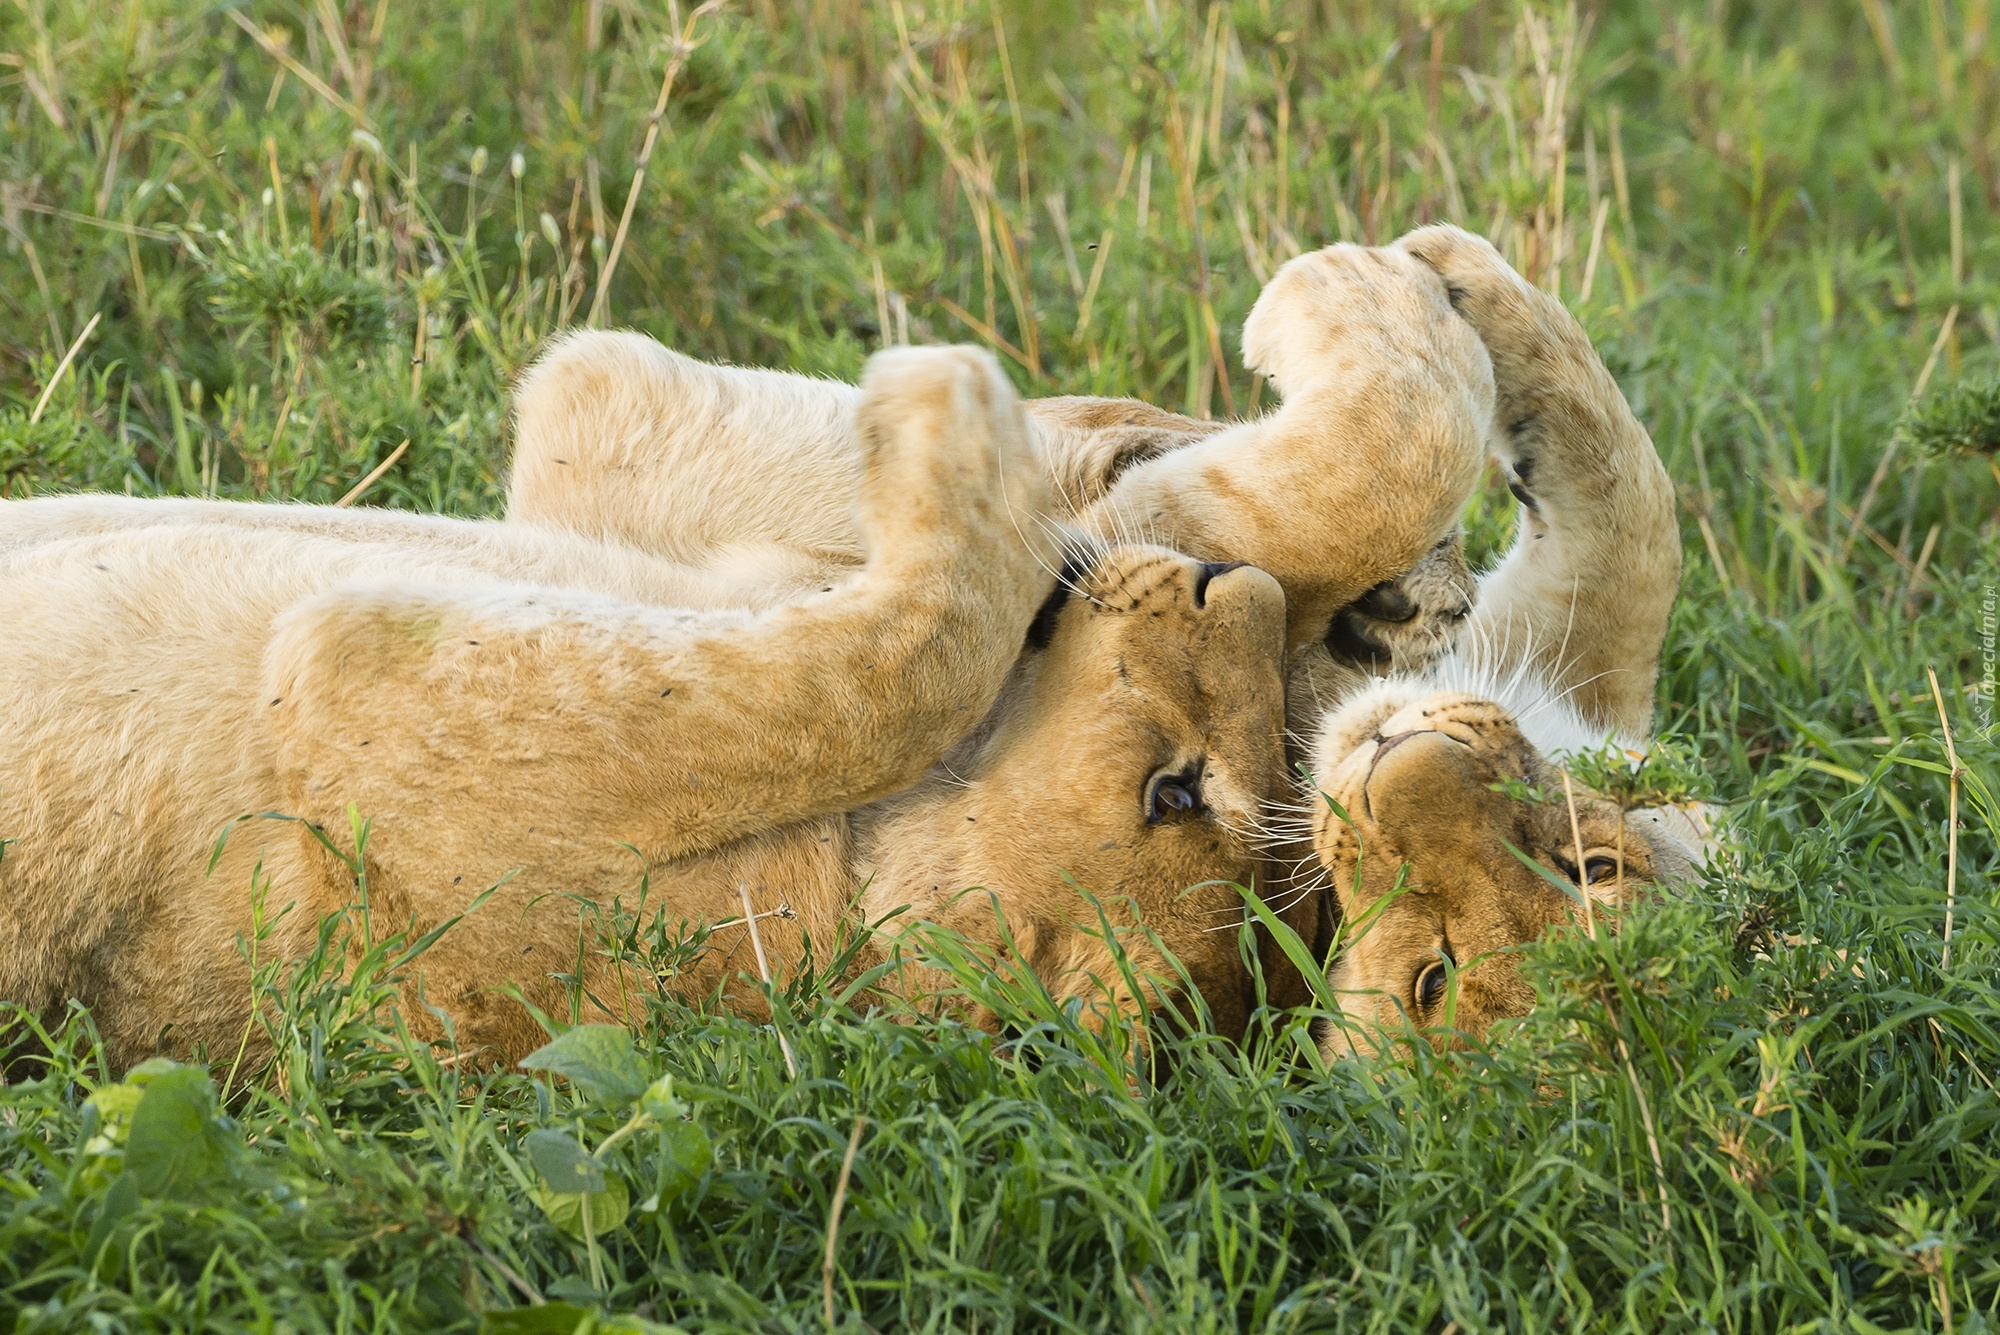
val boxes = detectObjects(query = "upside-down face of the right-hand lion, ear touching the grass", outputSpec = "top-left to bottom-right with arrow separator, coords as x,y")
1312,679 -> 1704,1057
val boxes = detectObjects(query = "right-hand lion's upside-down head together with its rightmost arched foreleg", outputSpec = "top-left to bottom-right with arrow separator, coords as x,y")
1308,228 -> 1706,1057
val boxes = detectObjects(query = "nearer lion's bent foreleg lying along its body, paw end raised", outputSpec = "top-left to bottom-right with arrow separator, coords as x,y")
284,348 -> 1054,873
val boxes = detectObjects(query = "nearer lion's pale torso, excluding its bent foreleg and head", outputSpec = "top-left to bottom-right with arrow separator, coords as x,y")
0,498 -> 868,1059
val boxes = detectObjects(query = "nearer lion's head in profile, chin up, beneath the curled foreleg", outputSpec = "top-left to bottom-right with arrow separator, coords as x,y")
862,546 -> 1284,1031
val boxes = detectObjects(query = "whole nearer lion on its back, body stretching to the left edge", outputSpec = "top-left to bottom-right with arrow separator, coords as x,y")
0,350 -> 1284,1059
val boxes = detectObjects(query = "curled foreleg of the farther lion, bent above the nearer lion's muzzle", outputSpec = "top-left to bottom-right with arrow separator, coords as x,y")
1086,246 -> 1492,650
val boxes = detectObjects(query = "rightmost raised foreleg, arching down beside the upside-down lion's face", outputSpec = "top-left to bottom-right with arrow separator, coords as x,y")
1396,226 -> 1680,737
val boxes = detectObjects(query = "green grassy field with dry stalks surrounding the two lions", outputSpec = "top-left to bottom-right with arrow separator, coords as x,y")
0,0 -> 2000,1333
